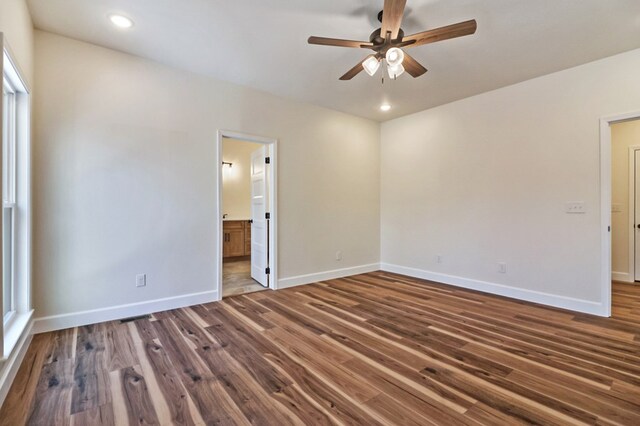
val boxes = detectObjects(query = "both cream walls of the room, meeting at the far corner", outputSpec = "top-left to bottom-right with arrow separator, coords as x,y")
34,19 -> 640,326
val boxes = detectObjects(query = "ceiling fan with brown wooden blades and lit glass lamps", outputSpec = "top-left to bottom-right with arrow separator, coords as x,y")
308,0 -> 477,80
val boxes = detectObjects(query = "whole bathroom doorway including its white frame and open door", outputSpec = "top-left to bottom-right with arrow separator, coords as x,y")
217,131 -> 277,299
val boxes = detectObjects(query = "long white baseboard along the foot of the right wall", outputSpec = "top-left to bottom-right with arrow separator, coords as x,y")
380,263 -> 607,317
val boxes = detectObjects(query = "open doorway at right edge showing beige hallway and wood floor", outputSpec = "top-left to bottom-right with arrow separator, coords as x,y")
611,119 -> 640,321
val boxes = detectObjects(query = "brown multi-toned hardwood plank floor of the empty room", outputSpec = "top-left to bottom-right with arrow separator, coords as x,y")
0,272 -> 640,426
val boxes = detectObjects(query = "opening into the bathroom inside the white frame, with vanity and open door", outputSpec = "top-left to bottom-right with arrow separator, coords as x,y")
222,137 -> 270,297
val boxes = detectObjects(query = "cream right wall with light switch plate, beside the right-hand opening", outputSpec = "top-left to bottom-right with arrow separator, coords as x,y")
381,50 -> 640,313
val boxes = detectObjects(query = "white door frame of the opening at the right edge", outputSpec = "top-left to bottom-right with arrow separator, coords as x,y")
600,111 -> 640,317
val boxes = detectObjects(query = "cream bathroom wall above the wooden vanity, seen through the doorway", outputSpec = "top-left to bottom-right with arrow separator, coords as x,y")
222,138 -> 264,220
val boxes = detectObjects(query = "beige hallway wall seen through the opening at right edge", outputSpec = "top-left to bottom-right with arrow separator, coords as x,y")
611,120 -> 640,281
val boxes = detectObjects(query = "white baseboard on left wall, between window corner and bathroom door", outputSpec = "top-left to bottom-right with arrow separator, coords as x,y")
33,290 -> 218,334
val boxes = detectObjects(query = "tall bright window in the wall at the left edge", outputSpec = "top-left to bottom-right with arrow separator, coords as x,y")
2,76 -> 17,323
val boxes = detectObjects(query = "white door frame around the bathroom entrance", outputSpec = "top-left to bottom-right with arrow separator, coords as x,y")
215,130 -> 278,300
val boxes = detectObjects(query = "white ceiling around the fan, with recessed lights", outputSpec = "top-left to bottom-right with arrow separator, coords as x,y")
28,0 -> 640,121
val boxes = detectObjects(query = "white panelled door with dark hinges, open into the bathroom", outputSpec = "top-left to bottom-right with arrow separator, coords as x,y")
251,146 -> 269,287
